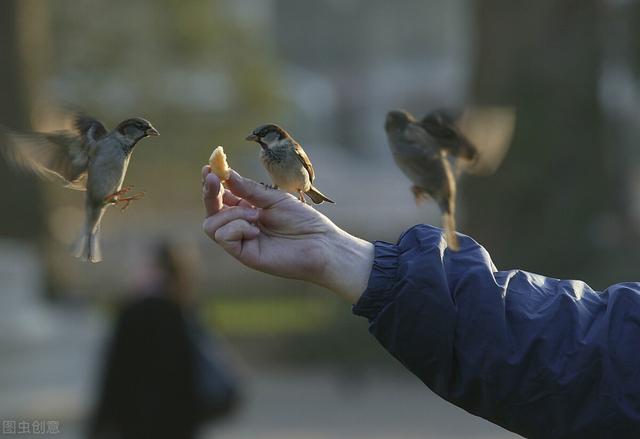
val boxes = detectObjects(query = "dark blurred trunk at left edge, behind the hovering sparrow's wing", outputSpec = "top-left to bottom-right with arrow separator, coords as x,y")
0,0 -> 45,242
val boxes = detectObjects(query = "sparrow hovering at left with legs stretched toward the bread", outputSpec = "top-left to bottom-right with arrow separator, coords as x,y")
0,114 -> 159,262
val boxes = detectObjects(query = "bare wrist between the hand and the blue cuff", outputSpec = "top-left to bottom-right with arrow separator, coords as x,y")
317,230 -> 375,303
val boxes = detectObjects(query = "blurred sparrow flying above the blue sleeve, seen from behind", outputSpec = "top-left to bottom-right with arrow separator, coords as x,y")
385,107 -> 515,251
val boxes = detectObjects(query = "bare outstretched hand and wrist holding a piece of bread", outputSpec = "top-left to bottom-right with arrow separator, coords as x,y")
202,166 -> 374,303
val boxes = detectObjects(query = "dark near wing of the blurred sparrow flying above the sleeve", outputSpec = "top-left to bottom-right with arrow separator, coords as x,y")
420,110 -> 477,160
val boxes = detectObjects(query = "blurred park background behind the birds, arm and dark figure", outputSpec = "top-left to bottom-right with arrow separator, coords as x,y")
0,0 -> 640,439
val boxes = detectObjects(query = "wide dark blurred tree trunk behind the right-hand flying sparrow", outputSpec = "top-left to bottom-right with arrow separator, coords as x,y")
462,0 -> 616,286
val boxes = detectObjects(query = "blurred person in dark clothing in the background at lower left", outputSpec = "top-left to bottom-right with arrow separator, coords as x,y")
89,242 -> 238,439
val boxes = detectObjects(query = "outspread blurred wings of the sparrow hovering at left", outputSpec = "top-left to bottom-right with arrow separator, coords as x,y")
0,116 -> 106,190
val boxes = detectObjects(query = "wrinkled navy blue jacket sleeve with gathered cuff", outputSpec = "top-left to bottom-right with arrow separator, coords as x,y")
353,225 -> 640,438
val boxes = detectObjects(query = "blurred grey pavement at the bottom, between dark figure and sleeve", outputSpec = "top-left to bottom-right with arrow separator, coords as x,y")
211,370 -> 518,439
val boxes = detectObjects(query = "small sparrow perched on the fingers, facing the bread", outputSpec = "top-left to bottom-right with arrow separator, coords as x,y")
246,124 -> 333,204
